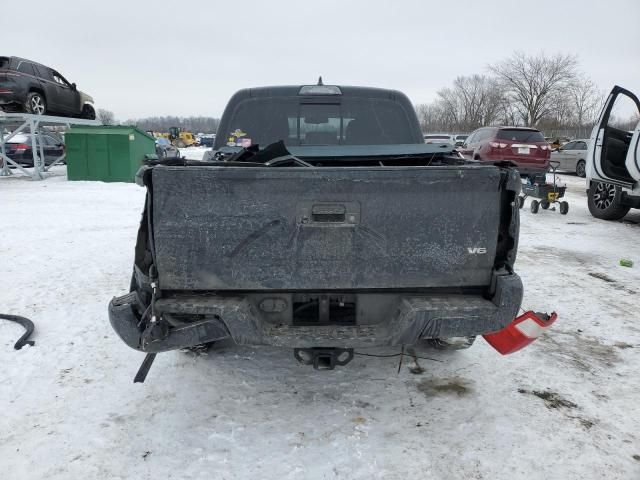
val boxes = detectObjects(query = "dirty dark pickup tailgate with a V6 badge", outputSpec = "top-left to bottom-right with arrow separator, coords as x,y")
152,166 -> 517,291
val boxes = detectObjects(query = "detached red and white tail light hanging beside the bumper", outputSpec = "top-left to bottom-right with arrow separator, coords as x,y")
483,310 -> 558,355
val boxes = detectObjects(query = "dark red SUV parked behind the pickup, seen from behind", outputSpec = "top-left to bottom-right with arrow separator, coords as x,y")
458,127 -> 551,176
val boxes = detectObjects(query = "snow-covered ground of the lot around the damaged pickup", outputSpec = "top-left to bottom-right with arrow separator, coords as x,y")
0,166 -> 640,480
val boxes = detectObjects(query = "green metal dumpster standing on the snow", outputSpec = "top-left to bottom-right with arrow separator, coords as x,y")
65,125 -> 156,182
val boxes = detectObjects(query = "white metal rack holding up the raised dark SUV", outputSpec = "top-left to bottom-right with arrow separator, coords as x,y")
0,112 -> 100,180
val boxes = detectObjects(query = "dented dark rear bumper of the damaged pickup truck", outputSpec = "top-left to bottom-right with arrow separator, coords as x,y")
109,274 -> 523,353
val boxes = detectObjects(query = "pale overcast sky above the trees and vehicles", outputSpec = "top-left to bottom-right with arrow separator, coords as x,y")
0,0 -> 640,120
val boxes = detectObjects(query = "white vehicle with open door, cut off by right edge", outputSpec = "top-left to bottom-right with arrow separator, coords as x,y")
586,86 -> 640,220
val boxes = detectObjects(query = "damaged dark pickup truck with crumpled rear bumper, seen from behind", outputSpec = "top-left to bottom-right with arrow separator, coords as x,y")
109,84 -> 540,376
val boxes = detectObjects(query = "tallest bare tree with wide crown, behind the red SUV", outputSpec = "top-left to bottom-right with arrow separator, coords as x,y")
489,52 -> 578,126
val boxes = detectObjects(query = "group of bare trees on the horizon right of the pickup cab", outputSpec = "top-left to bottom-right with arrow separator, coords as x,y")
416,53 -> 604,137
